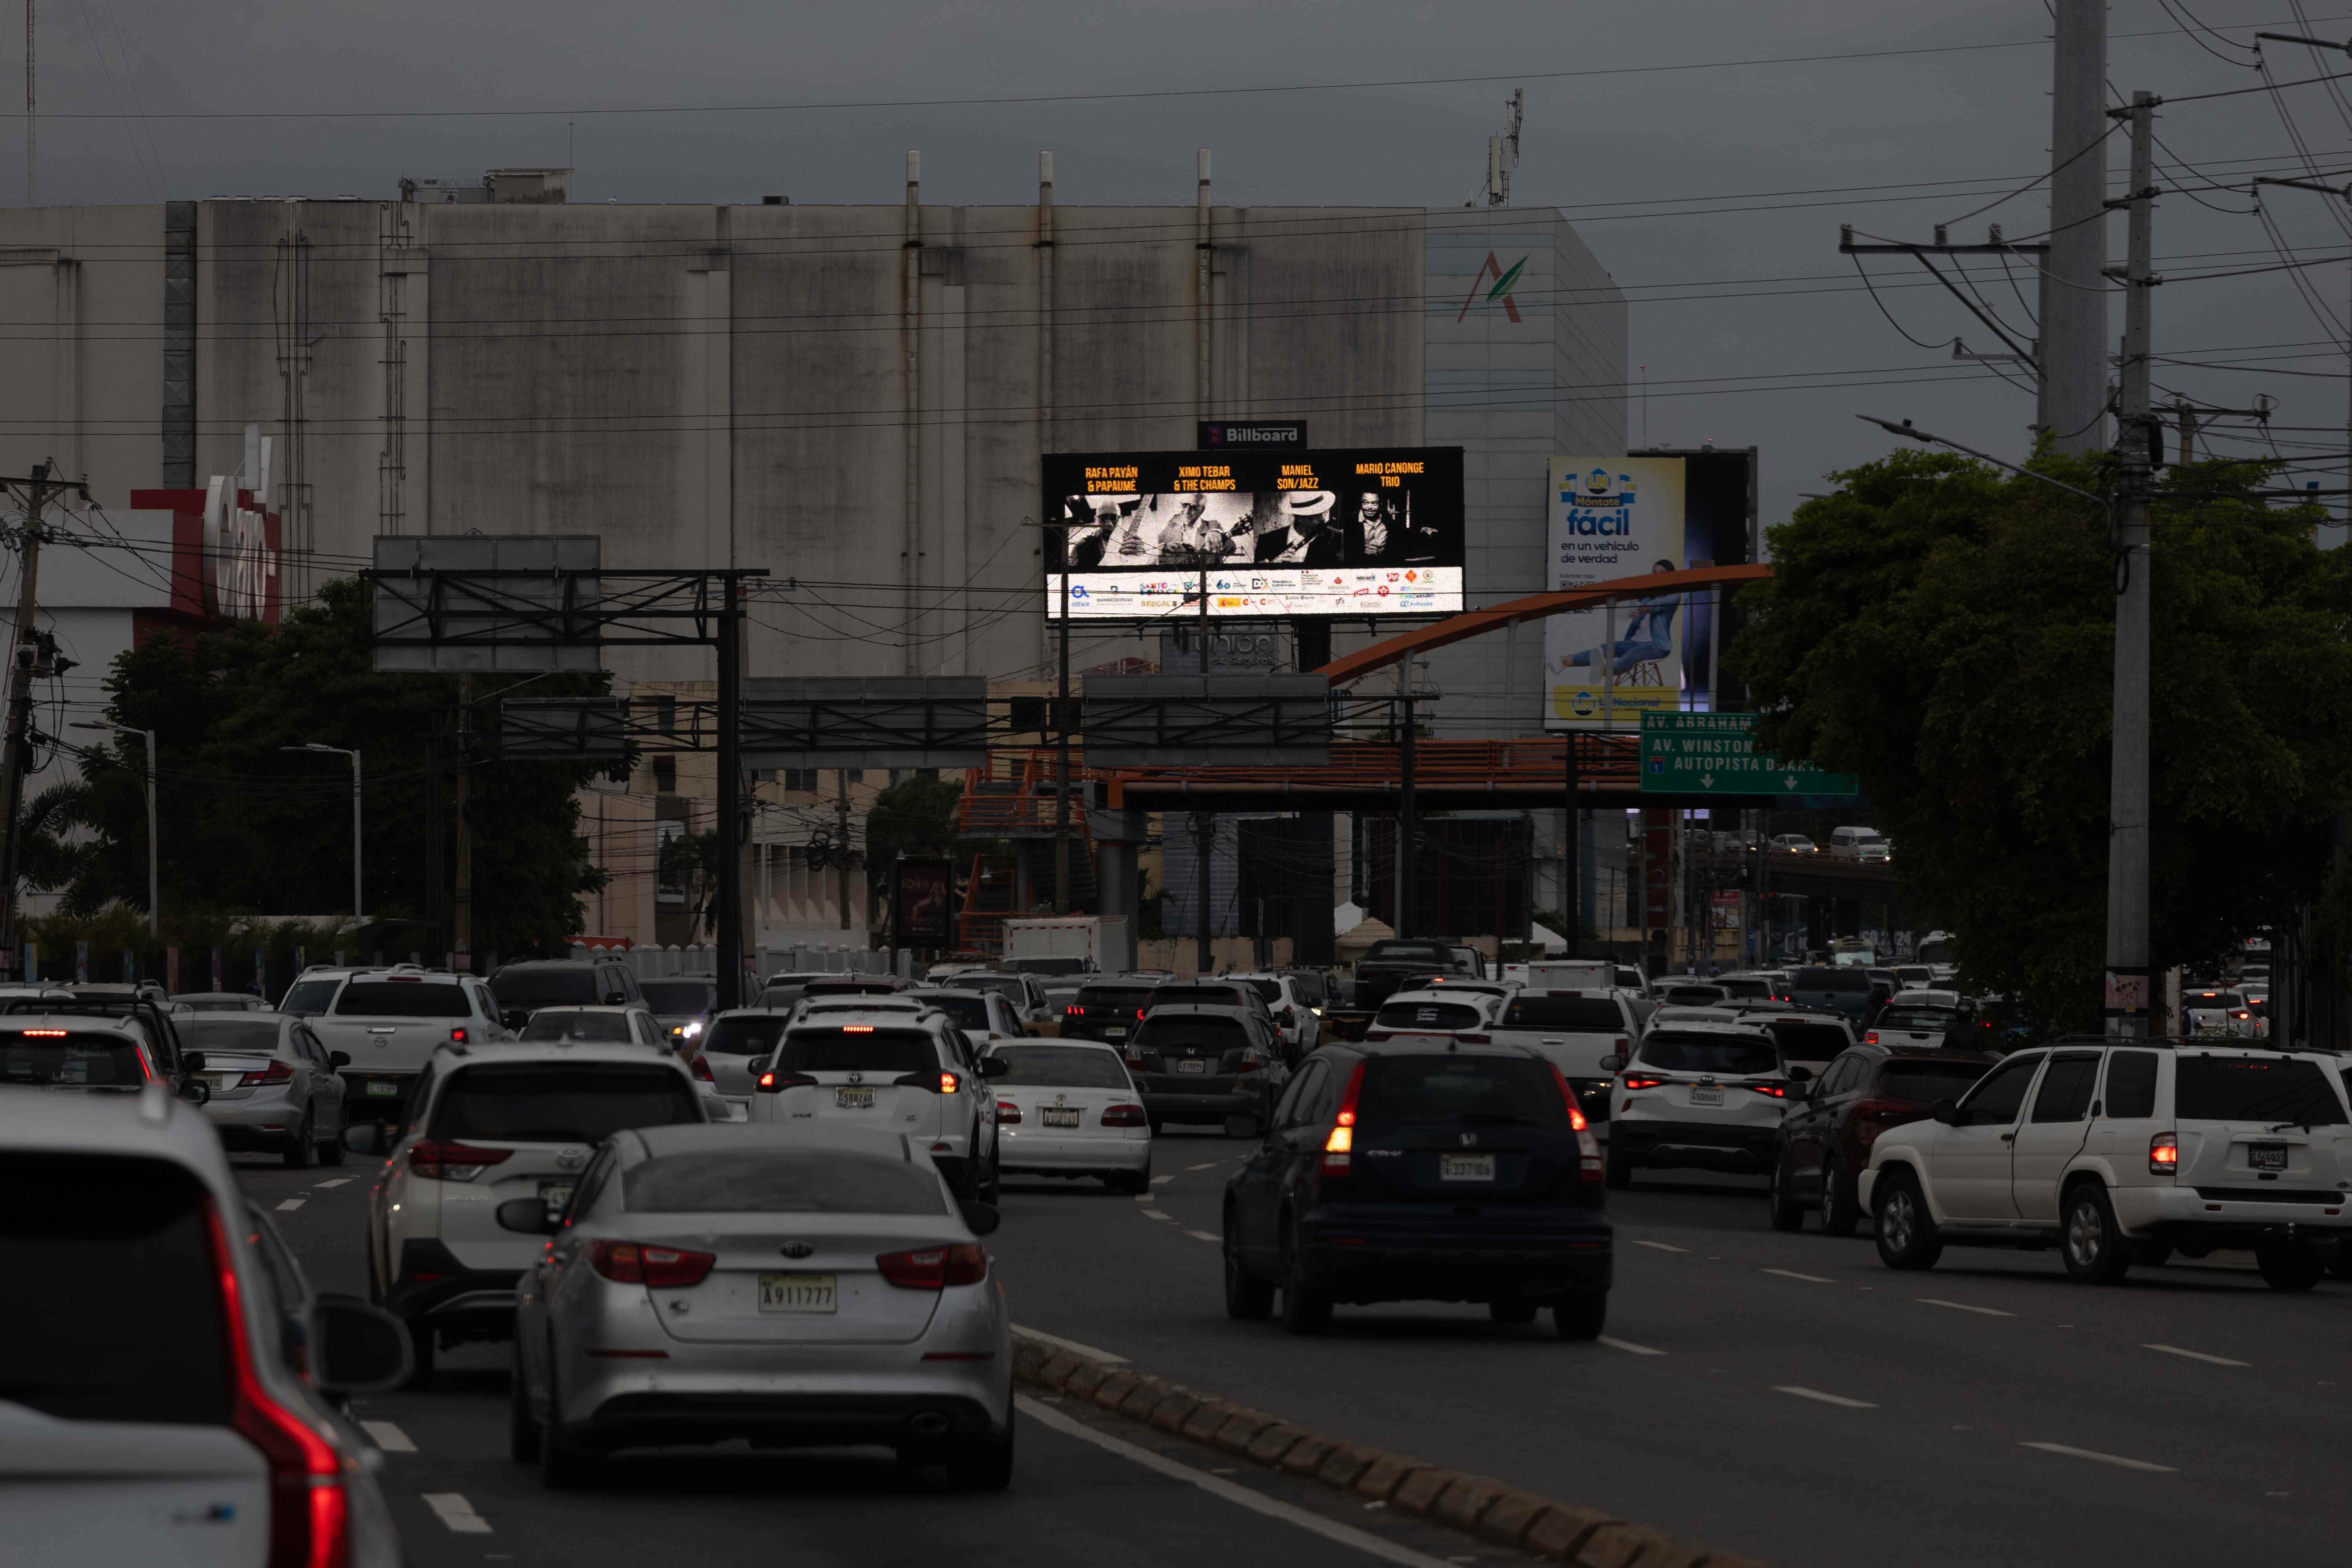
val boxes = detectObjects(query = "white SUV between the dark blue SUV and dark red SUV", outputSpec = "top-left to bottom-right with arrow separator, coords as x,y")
1599,1020 -> 1813,1187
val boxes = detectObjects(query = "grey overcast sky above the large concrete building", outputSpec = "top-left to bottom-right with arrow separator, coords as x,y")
0,0 -> 2352,524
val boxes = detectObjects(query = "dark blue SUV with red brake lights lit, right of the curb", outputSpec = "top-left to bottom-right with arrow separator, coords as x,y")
1225,1042 -> 1613,1340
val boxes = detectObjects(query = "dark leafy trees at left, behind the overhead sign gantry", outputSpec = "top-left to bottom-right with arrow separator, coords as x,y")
68,578 -> 609,952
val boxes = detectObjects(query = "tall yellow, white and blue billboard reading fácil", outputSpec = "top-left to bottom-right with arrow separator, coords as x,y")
1543,456 -> 1689,731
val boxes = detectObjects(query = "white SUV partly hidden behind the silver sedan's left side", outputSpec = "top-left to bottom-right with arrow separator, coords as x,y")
343,1044 -> 708,1382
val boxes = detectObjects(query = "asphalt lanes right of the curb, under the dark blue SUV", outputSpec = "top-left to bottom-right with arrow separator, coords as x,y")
1000,1131 -> 2352,1563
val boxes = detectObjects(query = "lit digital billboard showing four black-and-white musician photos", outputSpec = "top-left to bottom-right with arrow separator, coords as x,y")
1044,446 -> 1463,621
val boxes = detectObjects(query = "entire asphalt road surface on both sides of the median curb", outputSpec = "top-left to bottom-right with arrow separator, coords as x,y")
245,1129 -> 2352,1568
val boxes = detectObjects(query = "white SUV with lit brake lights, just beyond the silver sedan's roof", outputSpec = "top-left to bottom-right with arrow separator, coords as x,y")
750,1006 -> 1007,1203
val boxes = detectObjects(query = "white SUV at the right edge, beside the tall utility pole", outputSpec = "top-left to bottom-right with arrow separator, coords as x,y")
1860,1037 -> 2352,1290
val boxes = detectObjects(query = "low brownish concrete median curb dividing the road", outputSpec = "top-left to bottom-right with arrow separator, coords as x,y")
1014,1330 -> 1764,1568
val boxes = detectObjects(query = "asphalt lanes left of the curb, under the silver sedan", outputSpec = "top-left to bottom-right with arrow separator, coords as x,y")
238,1159 -> 1529,1568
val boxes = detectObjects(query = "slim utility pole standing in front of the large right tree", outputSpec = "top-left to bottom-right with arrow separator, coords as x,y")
2105,92 -> 2161,1037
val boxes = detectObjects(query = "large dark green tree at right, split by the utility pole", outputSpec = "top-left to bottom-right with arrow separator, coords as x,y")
1726,451 -> 2352,1027
